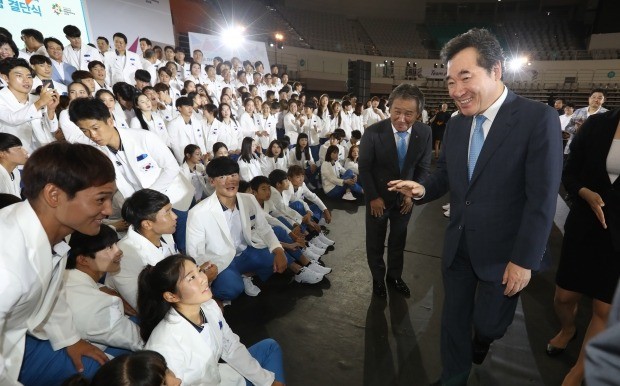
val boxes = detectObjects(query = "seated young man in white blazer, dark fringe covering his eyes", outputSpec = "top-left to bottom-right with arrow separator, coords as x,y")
187,157 -> 288,301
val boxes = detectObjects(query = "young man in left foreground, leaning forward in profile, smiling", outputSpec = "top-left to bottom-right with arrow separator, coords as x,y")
0,142 -> 116,385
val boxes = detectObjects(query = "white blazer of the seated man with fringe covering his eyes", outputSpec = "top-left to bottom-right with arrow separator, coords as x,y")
186,193 -> 280,272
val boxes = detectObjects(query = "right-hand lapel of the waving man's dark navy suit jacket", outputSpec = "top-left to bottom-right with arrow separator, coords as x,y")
472,91 -> 518,185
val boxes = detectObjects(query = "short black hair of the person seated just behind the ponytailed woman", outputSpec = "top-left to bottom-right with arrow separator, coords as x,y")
121,189 -> 170,232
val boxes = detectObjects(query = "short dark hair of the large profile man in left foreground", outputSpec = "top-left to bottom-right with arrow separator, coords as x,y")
22,142 -> 116,200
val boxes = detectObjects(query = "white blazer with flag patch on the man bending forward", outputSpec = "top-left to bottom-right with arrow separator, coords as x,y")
102,130 -> 194,211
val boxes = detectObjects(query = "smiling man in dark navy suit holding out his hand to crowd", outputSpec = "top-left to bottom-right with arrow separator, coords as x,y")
390,29 -> 562,385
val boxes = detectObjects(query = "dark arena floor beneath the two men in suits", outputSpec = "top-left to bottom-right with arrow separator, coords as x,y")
225,188 -> 589,386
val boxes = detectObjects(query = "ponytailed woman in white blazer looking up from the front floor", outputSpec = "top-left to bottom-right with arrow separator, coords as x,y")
138,254 -> 284,386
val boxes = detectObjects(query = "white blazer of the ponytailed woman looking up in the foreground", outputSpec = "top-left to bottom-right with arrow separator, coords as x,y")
145,300 -> 275,386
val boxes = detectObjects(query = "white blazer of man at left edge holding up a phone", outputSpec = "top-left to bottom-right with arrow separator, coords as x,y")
0,87 -> 58,154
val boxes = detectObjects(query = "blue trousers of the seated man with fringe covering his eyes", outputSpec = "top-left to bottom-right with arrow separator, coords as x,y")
211,246 -> 273,300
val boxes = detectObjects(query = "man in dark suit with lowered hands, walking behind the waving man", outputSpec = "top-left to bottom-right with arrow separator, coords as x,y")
359,83 -> 431,298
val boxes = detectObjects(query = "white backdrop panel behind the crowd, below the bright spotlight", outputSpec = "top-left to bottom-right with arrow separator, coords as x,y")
188,32 -> 269,72
